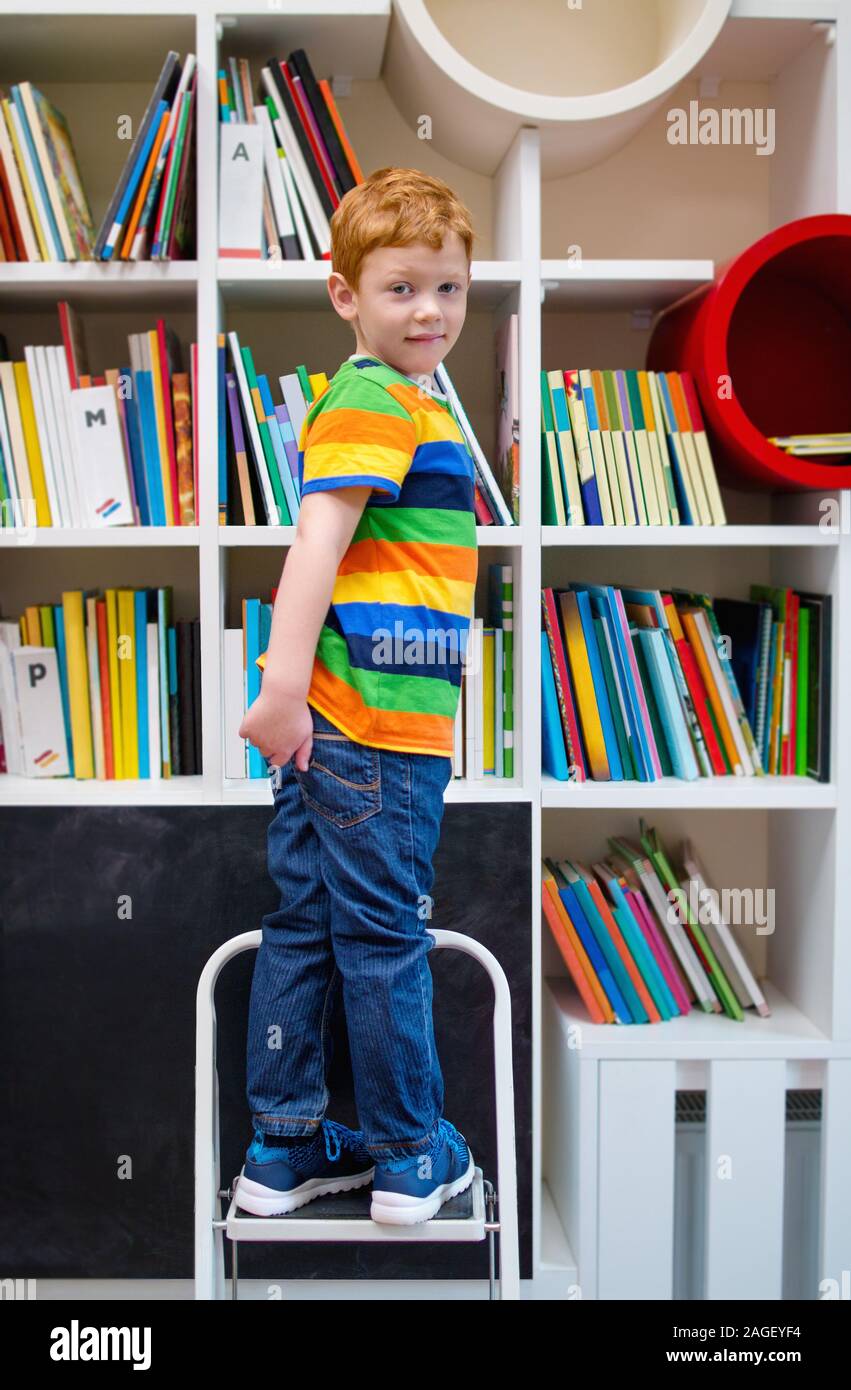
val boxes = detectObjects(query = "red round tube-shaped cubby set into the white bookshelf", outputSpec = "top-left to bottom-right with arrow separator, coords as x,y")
647,205 -> 851,492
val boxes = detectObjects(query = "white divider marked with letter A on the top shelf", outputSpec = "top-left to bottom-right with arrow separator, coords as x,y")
218,121 -> 263,260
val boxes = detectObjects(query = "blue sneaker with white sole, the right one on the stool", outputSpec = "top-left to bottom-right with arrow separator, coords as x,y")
370,1119 -> 476,1226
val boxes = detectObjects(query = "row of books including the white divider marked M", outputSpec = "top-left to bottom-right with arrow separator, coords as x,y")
0,308 -> 197,528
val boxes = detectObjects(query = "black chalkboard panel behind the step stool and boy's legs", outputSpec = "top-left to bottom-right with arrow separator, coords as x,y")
0,802 -> 531,1280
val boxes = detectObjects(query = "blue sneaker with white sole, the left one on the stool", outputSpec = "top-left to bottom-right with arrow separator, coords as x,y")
236,1120 -> 375,1216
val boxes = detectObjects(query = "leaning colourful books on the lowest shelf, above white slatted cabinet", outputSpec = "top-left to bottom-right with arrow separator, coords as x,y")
541,820 -> 773,1023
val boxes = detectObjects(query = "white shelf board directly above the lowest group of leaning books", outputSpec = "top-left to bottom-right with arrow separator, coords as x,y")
541,773 -> 838,810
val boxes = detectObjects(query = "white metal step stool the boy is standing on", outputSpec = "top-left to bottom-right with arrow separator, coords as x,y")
195,927 -> 520,1300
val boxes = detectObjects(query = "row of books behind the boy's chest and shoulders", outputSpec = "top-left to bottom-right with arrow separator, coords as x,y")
218,331 -> 517,525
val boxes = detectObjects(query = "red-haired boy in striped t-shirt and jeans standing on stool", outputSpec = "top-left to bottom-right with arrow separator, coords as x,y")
238,168 -> 478,1225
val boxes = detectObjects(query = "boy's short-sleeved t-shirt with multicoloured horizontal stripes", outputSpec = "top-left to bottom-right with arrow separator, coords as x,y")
259,353 -> 478,758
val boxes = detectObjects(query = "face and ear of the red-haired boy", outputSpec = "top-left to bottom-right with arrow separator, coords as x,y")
328,232 -> 471,377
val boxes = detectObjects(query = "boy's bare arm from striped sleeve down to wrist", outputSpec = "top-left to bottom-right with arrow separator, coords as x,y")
255,485 -> 373,699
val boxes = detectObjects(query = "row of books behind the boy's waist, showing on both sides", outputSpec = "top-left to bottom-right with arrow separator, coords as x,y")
224,564 -> 514,780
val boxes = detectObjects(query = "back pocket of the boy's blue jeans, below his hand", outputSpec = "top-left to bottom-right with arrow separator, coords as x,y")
293,728 -> 381,828
